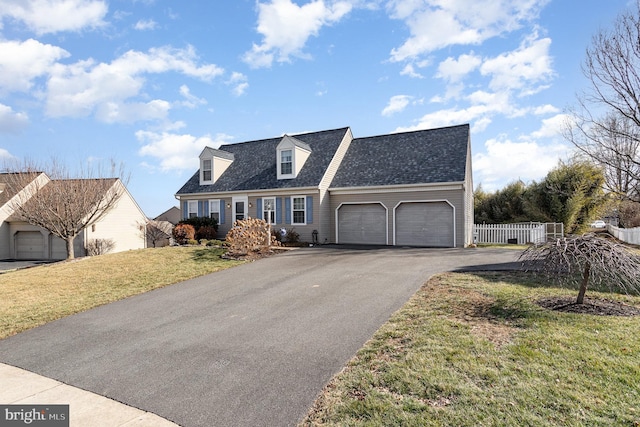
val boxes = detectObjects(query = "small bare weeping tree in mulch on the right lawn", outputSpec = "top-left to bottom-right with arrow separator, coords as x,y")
520,234 -> 640,304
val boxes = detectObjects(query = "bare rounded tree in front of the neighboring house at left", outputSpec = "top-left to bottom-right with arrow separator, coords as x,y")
4,159 -> 125,259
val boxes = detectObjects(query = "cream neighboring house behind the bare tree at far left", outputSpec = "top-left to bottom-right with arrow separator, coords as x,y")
0,173 -> 146,260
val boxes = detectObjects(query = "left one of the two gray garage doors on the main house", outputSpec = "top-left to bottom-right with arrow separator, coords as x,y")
338,203 -> 387,245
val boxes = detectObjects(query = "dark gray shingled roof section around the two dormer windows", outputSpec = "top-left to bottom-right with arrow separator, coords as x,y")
177,128 -> 349,194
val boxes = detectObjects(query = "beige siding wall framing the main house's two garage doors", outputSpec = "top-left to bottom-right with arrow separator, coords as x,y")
330,184 -> 469,247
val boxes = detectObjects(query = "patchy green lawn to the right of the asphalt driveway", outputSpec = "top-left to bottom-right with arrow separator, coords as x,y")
301,273 -> 640,426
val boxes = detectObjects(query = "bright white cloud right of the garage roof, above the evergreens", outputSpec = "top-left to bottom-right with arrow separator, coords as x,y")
473,136 -> 569,191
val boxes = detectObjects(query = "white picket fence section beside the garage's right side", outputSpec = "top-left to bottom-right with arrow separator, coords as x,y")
473,222 -> 564,244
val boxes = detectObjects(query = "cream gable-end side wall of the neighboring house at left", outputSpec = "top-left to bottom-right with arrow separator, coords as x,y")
84,182 -> 147,252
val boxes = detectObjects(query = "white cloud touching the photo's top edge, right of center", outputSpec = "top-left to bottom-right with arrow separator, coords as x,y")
387,0 -> 549,61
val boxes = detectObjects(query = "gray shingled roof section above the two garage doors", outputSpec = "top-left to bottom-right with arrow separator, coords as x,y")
331,124 -> 469,188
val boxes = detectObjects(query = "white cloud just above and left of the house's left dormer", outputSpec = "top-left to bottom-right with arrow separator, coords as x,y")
136,130 -> 232,172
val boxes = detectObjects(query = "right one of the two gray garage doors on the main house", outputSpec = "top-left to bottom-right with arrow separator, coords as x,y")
395,202 -> 455,248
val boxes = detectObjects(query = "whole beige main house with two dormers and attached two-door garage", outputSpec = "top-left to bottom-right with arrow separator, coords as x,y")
176,124 -> 473,247
